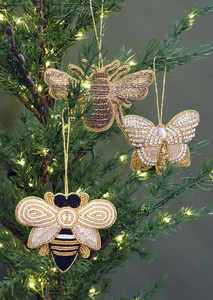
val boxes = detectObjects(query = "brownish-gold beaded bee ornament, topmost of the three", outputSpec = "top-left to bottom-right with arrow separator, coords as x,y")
44,59 -> 154,132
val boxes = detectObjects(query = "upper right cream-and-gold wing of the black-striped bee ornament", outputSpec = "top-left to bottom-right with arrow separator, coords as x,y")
78,199 -> 117,229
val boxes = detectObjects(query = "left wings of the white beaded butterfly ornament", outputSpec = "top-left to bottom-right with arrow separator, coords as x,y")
121,115 -> 162,171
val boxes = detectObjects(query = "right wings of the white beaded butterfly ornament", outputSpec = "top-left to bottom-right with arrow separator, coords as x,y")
166,110 -> 200,167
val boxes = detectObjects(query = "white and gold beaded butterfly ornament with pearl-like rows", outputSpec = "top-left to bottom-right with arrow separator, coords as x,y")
121,110 -> 199,174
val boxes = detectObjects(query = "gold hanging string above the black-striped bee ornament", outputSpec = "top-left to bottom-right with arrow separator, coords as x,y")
61,107 -> 71,195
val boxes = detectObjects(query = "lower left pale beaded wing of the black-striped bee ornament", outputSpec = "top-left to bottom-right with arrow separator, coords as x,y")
27,223 -> 61,248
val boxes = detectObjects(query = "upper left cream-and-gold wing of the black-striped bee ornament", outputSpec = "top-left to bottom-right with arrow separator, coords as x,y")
15,196 -> 58,227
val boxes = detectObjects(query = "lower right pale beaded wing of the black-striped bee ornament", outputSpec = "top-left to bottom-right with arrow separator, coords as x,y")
72,224 -> 101,250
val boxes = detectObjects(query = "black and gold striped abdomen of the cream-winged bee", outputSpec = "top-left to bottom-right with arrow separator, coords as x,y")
49,229 -> 81,272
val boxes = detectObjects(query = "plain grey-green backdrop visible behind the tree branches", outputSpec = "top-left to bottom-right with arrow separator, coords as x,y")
0,0 -> 213,300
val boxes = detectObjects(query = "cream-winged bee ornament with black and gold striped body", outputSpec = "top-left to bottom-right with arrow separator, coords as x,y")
15,192 -> 117,272
